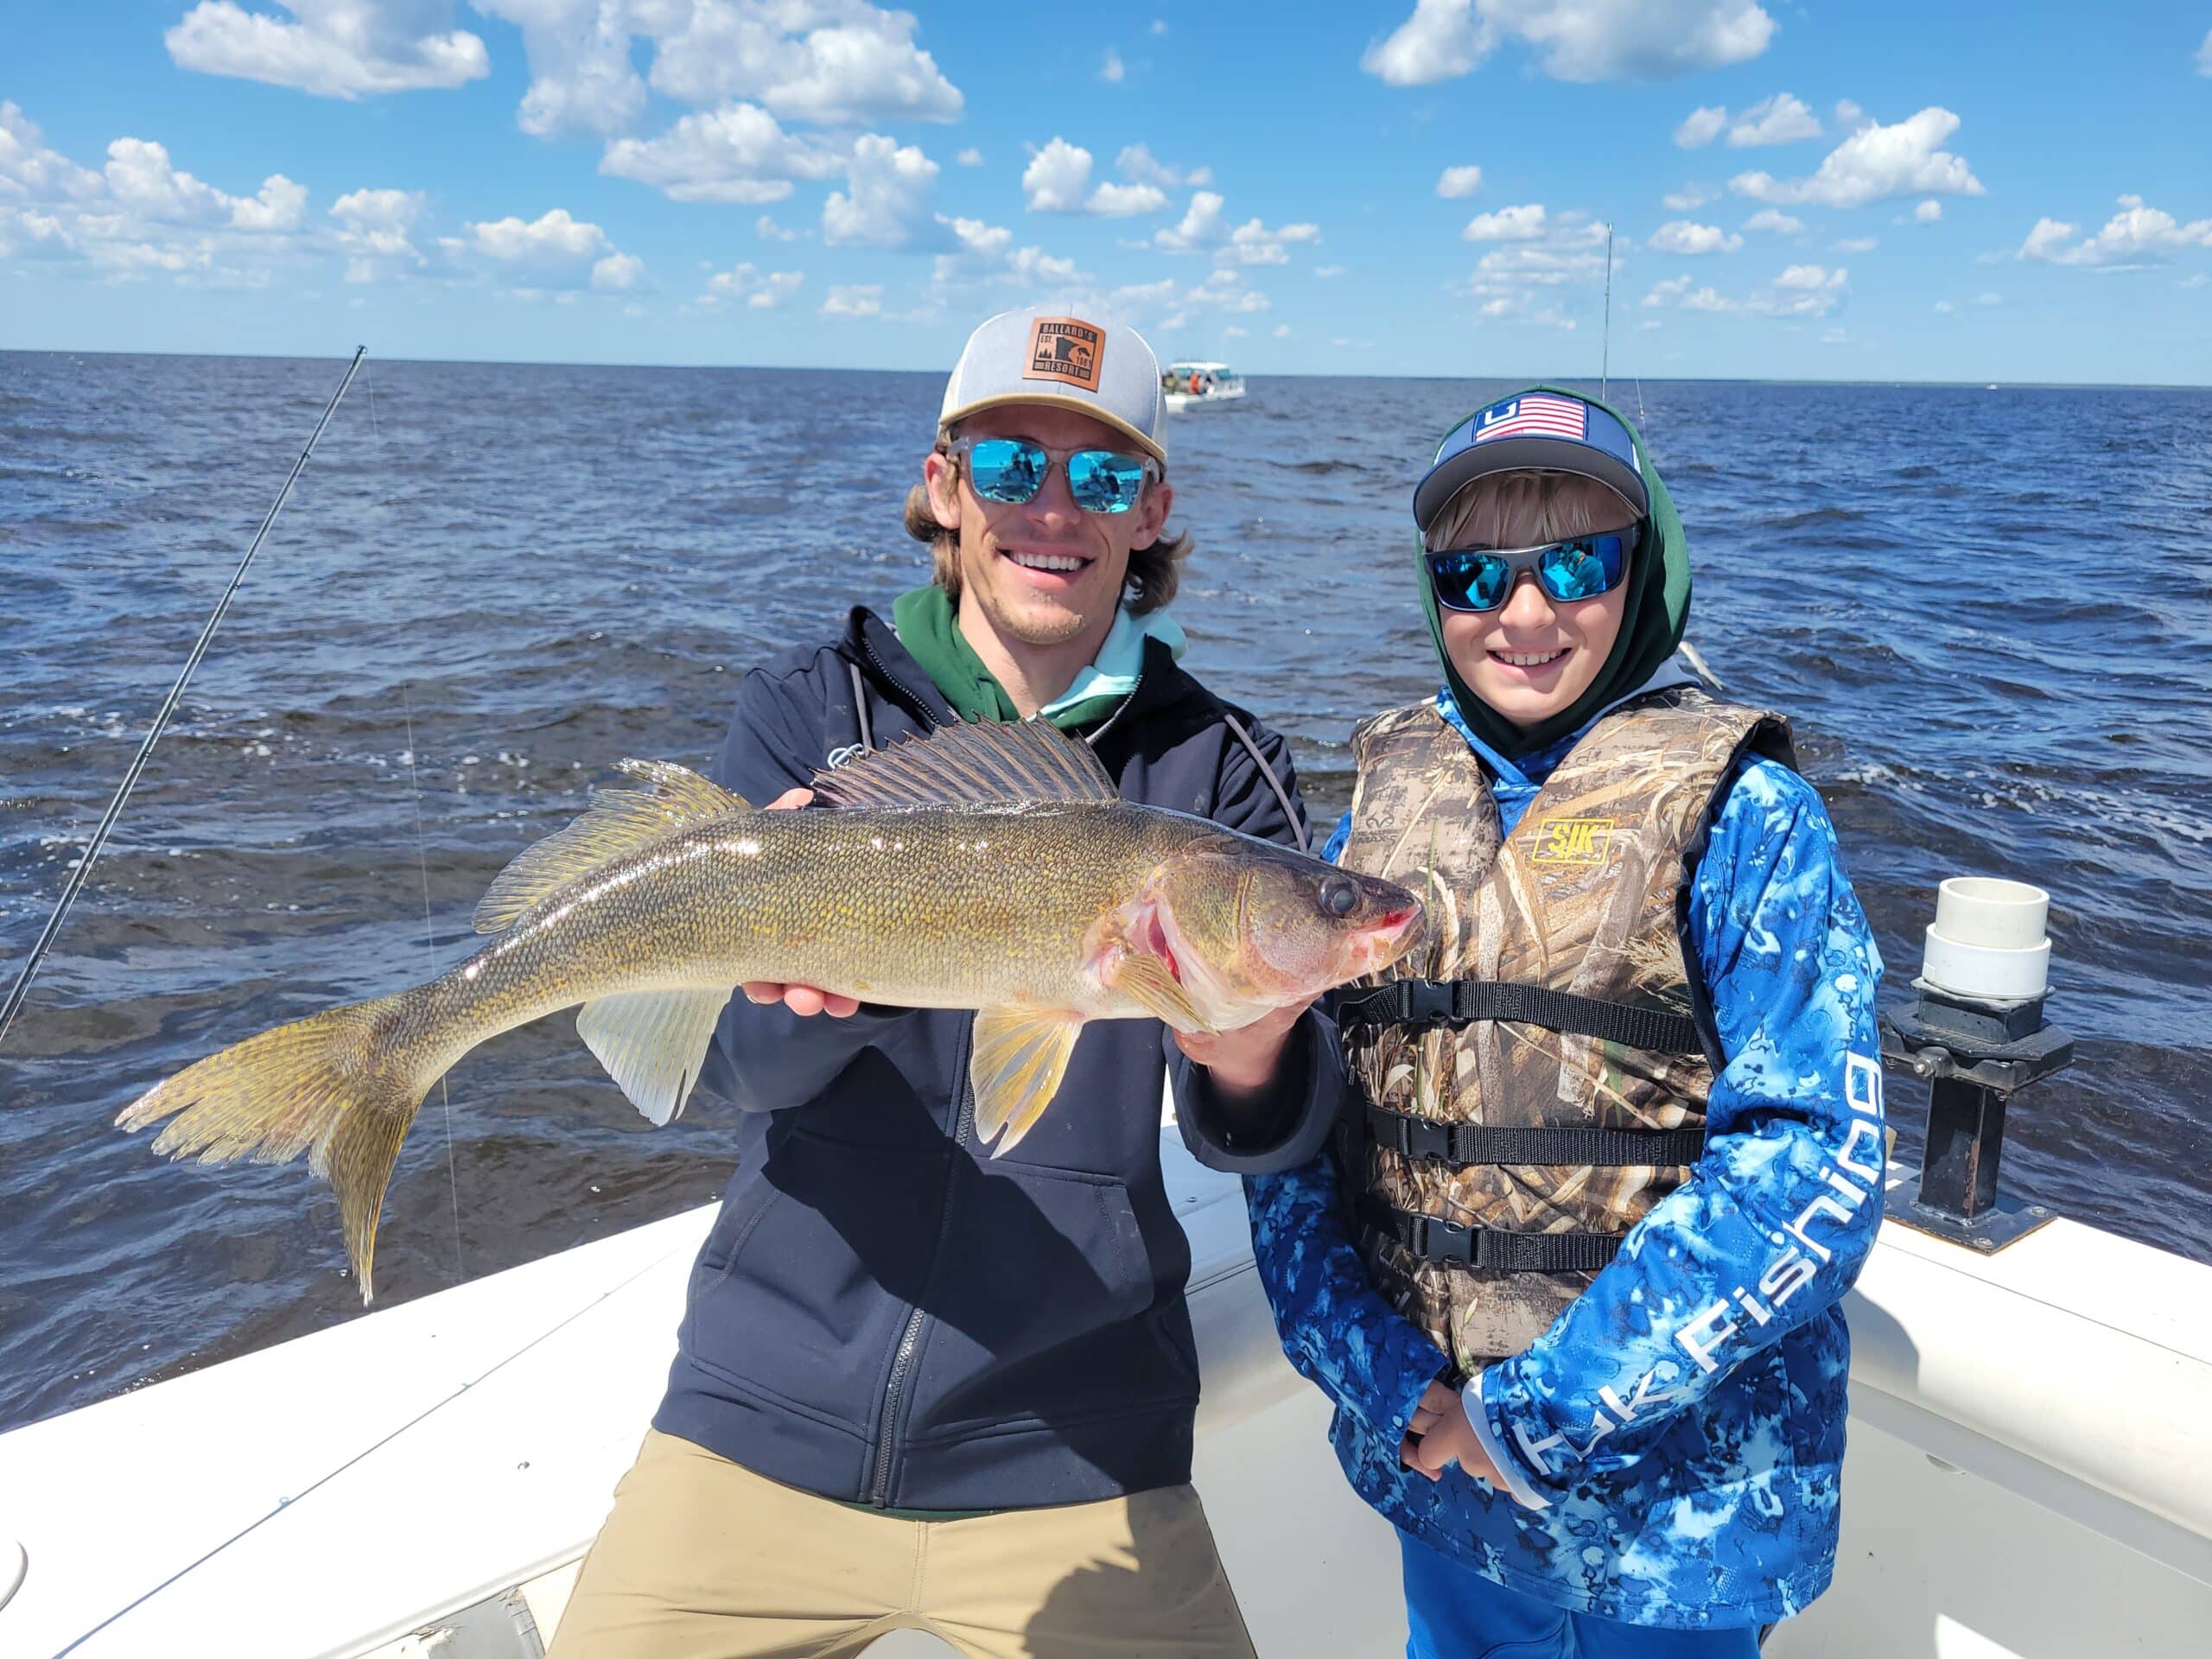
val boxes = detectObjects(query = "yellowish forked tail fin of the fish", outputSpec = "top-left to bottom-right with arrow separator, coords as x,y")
115,987 -> 440,1300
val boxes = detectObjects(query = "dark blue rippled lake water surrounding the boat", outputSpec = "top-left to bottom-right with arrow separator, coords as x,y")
0,354 -> 2212,1429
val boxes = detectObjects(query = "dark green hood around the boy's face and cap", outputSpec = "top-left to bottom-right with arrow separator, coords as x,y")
1414,385 -> 1690,761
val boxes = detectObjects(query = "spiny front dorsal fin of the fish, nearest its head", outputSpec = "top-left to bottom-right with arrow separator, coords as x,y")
814,719 -> 1122,807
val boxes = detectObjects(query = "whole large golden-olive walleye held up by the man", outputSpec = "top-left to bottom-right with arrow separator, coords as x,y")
115,721 -> 1422,1300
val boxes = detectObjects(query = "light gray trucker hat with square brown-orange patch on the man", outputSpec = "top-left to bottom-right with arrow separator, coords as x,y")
938,305 -> 1168,465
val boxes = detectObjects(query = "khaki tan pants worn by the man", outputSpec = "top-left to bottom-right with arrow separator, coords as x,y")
549,1429 -> 1252,1659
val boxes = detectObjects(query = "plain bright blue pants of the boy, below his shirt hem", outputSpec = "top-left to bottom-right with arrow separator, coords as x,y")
1398,1533 -> 1758,1659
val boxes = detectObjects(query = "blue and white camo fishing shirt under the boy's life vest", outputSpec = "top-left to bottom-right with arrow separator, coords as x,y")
1245,692 -> 1883,1628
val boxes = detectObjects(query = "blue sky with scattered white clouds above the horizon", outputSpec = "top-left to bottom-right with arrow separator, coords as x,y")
0,0 -> 2212,385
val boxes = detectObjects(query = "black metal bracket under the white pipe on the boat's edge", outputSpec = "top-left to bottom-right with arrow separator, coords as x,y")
1878,984 -> 2073,1255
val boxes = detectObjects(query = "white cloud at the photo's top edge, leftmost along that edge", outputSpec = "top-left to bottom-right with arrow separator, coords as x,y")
162,0 -> 491,98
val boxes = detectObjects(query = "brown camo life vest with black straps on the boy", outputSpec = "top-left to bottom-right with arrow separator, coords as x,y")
1338,688 -> 1789,1371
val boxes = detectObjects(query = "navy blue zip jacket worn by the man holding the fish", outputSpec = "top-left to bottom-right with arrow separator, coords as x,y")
655,611 -> 1334,1509
